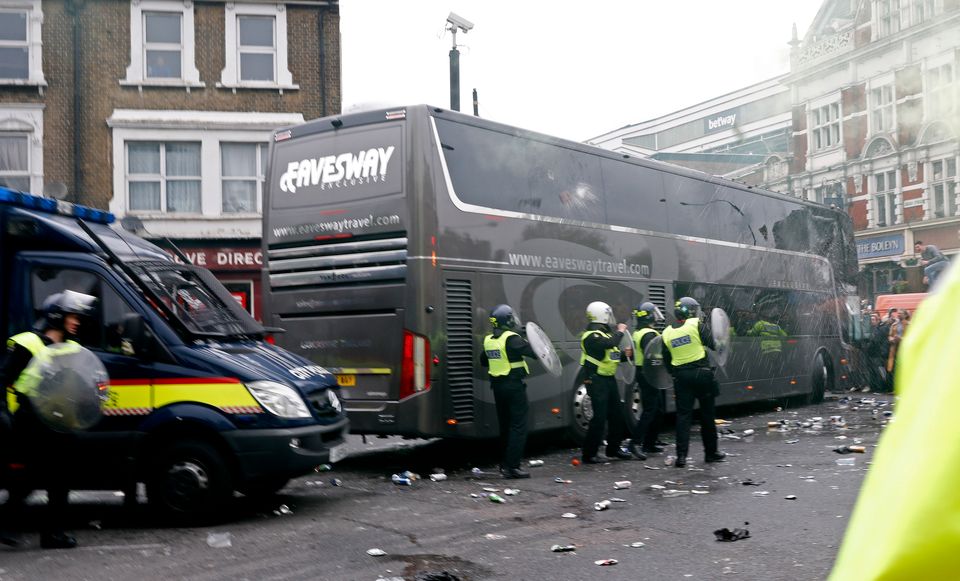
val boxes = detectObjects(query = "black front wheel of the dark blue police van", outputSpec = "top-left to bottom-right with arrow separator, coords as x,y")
147,440 -> 233,521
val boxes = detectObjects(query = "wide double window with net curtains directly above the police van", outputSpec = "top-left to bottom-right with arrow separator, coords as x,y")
127,141 -> 201,214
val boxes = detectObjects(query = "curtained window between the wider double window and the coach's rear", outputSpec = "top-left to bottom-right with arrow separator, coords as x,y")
220,142 -> 267,214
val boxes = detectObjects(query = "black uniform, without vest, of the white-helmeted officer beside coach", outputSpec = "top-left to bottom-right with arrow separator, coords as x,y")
578,323 -> 630,463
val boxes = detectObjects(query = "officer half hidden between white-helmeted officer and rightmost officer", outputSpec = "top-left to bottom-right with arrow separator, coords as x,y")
628,301 -> 667,459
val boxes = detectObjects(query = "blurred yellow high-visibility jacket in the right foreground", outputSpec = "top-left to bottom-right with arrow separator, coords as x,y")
830,265 -> 960,581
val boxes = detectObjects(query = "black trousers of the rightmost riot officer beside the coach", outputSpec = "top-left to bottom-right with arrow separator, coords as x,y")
674,367 -> 719,458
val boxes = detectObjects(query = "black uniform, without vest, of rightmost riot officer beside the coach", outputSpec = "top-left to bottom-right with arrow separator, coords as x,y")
662,318 -> 725,466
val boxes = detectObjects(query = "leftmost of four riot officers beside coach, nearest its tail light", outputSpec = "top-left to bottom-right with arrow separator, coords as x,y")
480,305 -> 536,478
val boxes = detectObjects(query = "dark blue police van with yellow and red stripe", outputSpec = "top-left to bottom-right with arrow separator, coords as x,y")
0,188 -> 348,520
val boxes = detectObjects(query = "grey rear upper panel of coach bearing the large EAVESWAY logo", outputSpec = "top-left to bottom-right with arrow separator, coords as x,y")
270,124 -> 403,209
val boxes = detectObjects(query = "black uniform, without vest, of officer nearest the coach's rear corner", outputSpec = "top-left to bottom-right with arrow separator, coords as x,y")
480,329 -> 537,471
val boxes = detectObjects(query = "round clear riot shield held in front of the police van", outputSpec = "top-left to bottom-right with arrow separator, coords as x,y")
24,343 -> 109,432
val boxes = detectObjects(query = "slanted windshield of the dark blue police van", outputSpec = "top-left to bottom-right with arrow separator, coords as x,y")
131,262 -> 263,336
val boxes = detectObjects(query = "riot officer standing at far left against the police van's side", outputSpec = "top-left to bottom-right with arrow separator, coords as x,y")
0,291 -> 96,549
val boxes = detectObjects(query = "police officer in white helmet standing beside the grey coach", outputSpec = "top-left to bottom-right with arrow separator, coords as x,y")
578,301 -> 631,464
